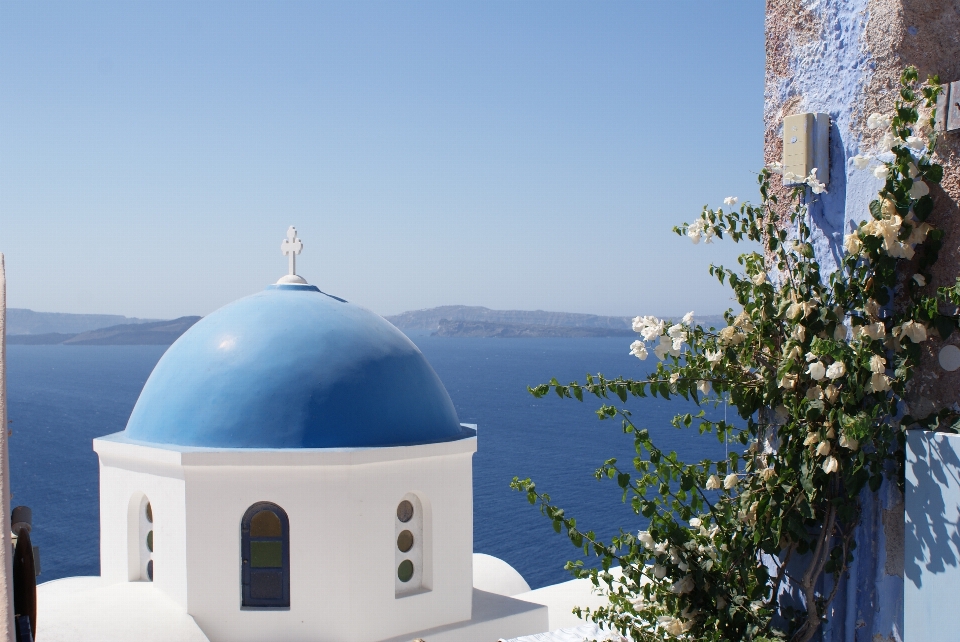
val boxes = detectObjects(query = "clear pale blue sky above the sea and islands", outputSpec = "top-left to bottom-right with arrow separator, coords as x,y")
0,0 -> 764,318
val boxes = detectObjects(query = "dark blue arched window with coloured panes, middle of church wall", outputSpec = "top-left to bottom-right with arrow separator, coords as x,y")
240,502 -> 290,607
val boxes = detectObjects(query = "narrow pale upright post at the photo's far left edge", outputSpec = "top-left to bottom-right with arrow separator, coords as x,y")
0,254 -> 16,642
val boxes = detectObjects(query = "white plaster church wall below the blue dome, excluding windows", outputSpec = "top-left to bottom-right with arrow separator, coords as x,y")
97,437 -> 476,642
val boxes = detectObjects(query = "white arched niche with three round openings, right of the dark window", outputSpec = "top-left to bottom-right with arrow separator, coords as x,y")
393,493 -> 430,597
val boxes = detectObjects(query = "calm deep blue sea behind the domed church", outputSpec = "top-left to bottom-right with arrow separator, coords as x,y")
7,336 -> 723,588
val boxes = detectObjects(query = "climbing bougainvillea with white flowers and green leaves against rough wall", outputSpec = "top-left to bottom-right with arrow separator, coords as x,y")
512,68 -> 948,642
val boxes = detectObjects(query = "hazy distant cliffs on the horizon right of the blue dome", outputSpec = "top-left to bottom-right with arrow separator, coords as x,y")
386,305 -> 726,338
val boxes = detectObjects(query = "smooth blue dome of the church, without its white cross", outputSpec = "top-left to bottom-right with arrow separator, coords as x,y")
123,285 -> 464,448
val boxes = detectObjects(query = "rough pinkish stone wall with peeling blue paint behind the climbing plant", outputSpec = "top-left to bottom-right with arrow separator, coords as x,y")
764,0 -> 960,642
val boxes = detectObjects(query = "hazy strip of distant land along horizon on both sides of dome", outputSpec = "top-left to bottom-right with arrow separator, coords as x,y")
7,305 -> 726,345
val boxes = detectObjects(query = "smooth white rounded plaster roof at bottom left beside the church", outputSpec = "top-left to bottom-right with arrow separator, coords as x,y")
37,577 -> 210,642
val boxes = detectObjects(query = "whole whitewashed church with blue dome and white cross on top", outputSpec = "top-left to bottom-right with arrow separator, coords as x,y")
38,228 -> 608,642
